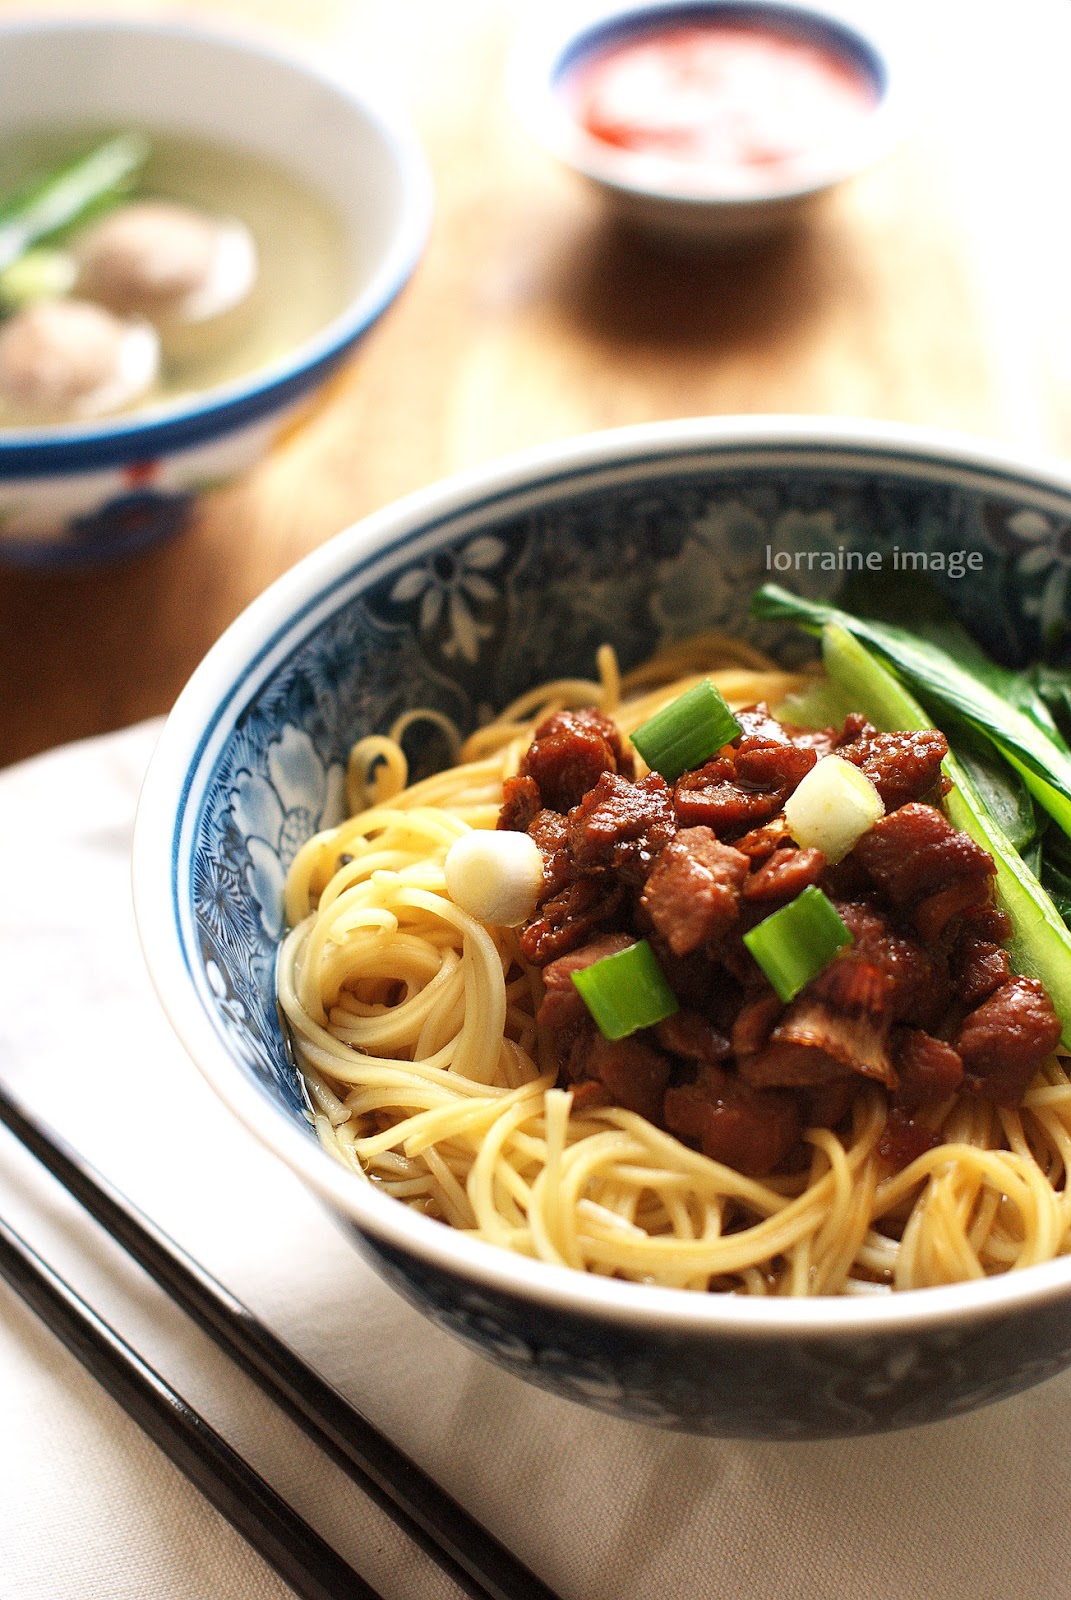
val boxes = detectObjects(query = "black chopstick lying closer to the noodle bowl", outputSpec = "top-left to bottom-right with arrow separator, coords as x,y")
0,1086 -> 557,1600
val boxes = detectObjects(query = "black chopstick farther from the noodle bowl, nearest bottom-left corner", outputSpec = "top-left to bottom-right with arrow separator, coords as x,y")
0,1219 -> 381,1600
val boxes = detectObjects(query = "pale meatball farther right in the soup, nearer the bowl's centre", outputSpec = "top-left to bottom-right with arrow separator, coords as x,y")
74,200 -> 256,323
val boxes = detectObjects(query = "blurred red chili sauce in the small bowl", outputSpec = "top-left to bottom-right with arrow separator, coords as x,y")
564,18 -> 877,194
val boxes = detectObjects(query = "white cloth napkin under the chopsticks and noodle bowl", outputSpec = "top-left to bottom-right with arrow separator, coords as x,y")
0,725 -> 1071,1600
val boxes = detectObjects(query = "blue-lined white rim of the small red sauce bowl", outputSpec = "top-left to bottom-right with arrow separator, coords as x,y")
507,0 -> 914,216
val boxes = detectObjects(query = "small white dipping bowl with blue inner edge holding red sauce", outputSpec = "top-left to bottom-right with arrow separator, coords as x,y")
509,0 -> 909,245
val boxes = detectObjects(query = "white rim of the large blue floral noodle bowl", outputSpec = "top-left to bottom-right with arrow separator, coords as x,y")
131,414 -> 1071,1339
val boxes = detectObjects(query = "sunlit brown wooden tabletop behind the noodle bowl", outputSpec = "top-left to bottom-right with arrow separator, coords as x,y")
0,0 -> 1071,762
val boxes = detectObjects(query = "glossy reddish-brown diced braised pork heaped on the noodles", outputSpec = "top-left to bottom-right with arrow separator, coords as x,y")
498,706 -> 1061,1176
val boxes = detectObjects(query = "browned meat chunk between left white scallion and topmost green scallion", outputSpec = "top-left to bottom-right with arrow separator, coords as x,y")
568,773 -> 677,886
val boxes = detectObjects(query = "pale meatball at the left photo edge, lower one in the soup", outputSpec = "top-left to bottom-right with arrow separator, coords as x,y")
0,299 -> 160,424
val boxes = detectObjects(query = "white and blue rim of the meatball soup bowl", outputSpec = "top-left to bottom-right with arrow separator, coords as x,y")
0,16 -> 434,477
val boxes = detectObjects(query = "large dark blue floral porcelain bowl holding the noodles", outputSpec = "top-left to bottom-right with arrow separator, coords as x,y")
134,418 -> 1071,1438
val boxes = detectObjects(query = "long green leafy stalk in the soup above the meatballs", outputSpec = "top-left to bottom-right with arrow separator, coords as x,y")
0,133 -> 149,272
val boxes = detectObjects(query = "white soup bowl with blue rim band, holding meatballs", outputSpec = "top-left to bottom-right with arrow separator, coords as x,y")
0,19 -> 431,566
